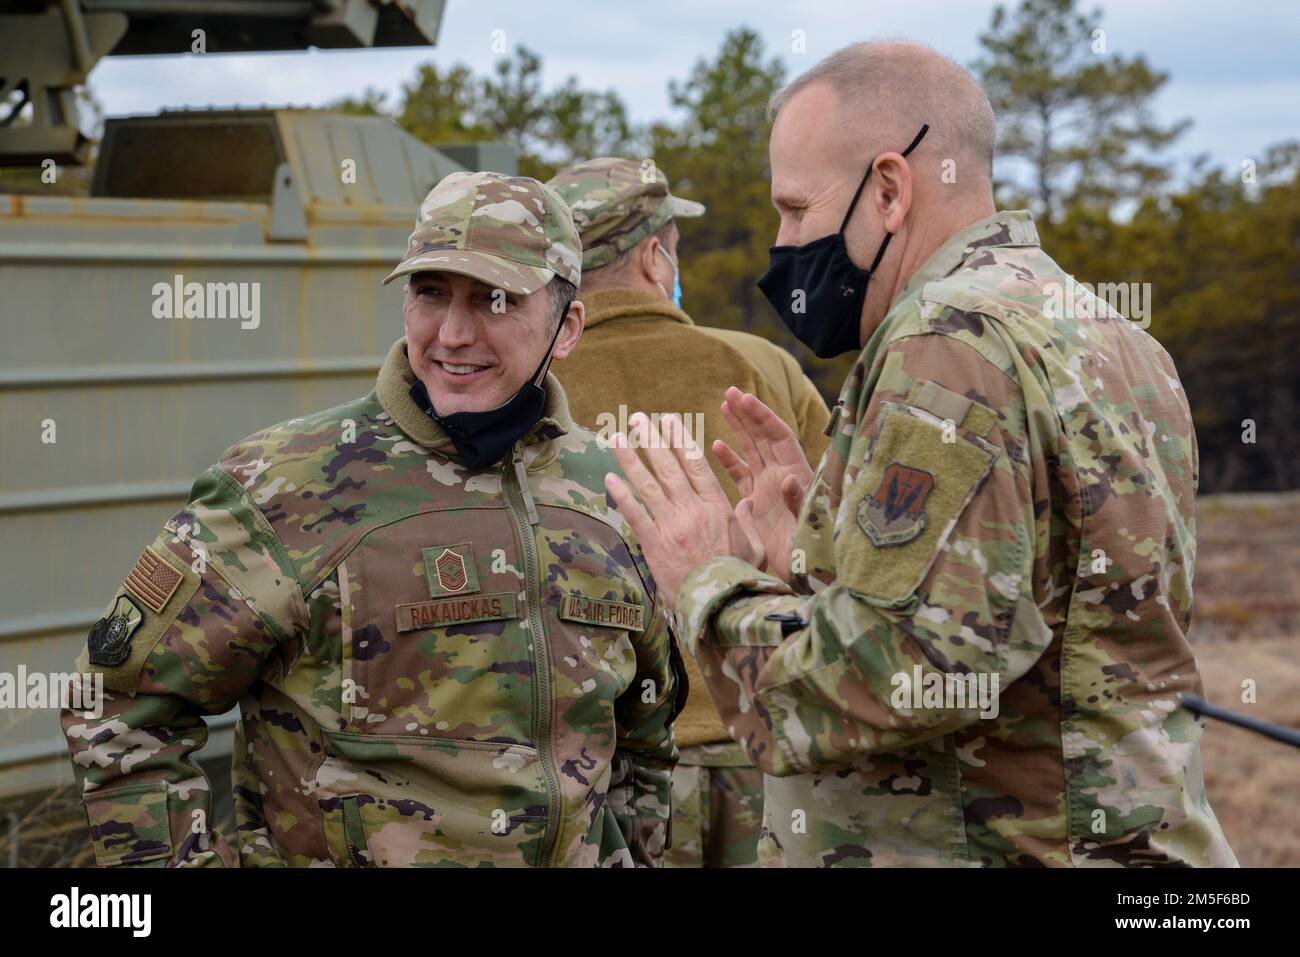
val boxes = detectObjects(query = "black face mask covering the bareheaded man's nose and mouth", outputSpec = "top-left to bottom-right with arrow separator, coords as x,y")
758,124 -> 930,359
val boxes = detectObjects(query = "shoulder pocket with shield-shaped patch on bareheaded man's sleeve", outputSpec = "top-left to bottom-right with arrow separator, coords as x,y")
835,402 -> 998,607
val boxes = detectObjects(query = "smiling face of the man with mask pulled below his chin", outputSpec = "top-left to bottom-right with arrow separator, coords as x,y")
402,272 -> 582,415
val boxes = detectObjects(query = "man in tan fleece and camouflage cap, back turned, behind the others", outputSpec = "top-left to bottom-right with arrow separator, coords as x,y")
547,156 -> 829,867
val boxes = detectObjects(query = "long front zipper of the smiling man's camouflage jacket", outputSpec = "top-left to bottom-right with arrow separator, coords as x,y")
503,446 -> 560,867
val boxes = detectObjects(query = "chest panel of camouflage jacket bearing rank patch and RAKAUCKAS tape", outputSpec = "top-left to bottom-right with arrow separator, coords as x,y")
339,508 -> 534,745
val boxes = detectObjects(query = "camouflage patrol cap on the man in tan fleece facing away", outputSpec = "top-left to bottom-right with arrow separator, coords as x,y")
546,156 -> 705,269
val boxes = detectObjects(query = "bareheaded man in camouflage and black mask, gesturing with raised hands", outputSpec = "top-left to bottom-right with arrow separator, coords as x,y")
607,43 -> 1235,866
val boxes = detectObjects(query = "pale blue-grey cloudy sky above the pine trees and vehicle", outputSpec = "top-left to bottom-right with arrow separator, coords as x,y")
91,0 -> 1300,178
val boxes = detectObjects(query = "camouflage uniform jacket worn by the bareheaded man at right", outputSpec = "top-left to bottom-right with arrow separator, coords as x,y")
679,212 -> 1235,866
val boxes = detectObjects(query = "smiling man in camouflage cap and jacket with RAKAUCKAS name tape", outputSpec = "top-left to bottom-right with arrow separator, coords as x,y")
62,173 -> 681,867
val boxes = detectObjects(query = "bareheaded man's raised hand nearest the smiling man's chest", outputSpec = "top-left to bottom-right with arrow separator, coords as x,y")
605,412 -> 762,609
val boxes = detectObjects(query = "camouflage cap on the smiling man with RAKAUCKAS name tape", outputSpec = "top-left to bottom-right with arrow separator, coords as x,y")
384,172 -> 582,295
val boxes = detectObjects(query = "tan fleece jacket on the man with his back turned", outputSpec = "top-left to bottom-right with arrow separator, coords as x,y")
551,290 -> 831,748
